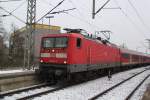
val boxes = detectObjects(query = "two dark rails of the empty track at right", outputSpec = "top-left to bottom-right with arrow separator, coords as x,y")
89,69 -> 150,100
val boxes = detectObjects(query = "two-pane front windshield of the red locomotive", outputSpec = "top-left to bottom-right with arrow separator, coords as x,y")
42,37 -> 68,48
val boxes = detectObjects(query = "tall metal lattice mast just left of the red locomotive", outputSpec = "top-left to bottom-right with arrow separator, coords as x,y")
24,0 -> 36,69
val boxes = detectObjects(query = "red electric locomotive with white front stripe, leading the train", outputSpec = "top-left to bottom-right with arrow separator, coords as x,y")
40,29 -> 150,80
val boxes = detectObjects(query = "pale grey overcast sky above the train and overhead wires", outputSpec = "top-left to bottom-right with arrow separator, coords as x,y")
0,0 -> 150,52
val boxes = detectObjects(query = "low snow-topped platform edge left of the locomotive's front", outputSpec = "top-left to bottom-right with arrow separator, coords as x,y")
0,69 -> 39,91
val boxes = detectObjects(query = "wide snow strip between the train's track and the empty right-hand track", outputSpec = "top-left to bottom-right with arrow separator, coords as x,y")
31,68 -> 150,100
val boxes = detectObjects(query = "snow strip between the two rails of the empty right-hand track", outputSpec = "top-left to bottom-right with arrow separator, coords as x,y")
98,70 -> 150,100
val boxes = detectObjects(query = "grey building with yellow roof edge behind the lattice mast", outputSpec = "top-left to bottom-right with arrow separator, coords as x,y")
9,24 -> 61,64
